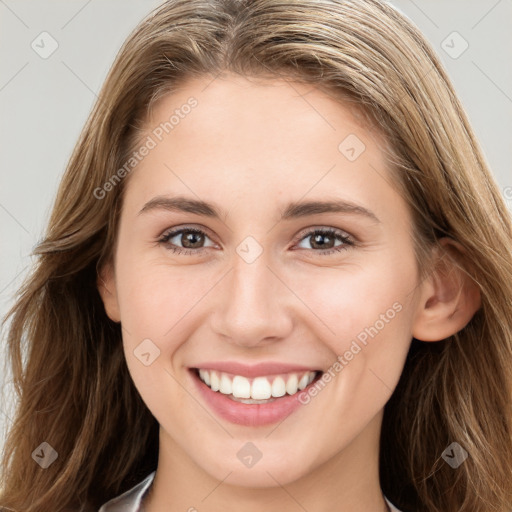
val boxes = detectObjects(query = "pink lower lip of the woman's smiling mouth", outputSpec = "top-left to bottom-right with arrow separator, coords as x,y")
189,369 -> 321,427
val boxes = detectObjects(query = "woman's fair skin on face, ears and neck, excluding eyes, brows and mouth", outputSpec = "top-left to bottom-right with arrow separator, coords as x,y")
98,74 -> 479,512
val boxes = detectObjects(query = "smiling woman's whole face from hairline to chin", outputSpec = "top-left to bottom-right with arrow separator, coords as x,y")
99,75 -> 419,486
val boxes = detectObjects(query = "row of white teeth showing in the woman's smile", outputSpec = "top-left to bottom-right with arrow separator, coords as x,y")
199,369 -> 317,403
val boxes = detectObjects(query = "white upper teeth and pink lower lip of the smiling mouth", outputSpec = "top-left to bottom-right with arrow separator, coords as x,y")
189,368 -> 323,426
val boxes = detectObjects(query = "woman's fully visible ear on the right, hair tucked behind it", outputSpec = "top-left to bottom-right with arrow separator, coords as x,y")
413,238 -> 481,341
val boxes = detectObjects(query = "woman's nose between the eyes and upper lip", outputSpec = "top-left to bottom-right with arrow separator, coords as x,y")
211,248 -> 297,347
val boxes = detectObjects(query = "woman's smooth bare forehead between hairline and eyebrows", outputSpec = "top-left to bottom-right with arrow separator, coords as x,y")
121,75 -> 408,228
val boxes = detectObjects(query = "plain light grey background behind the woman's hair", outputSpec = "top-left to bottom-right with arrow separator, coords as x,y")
0,0 -> 512,452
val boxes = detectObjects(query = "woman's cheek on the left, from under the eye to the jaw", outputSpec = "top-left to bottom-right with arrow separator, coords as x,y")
117,257 -> 212,416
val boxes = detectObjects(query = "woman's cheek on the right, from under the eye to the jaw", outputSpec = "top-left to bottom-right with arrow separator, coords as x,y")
289,251 -> 418,410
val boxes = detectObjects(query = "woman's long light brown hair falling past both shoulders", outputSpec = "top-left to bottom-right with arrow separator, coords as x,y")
0,0 -> 512,512
